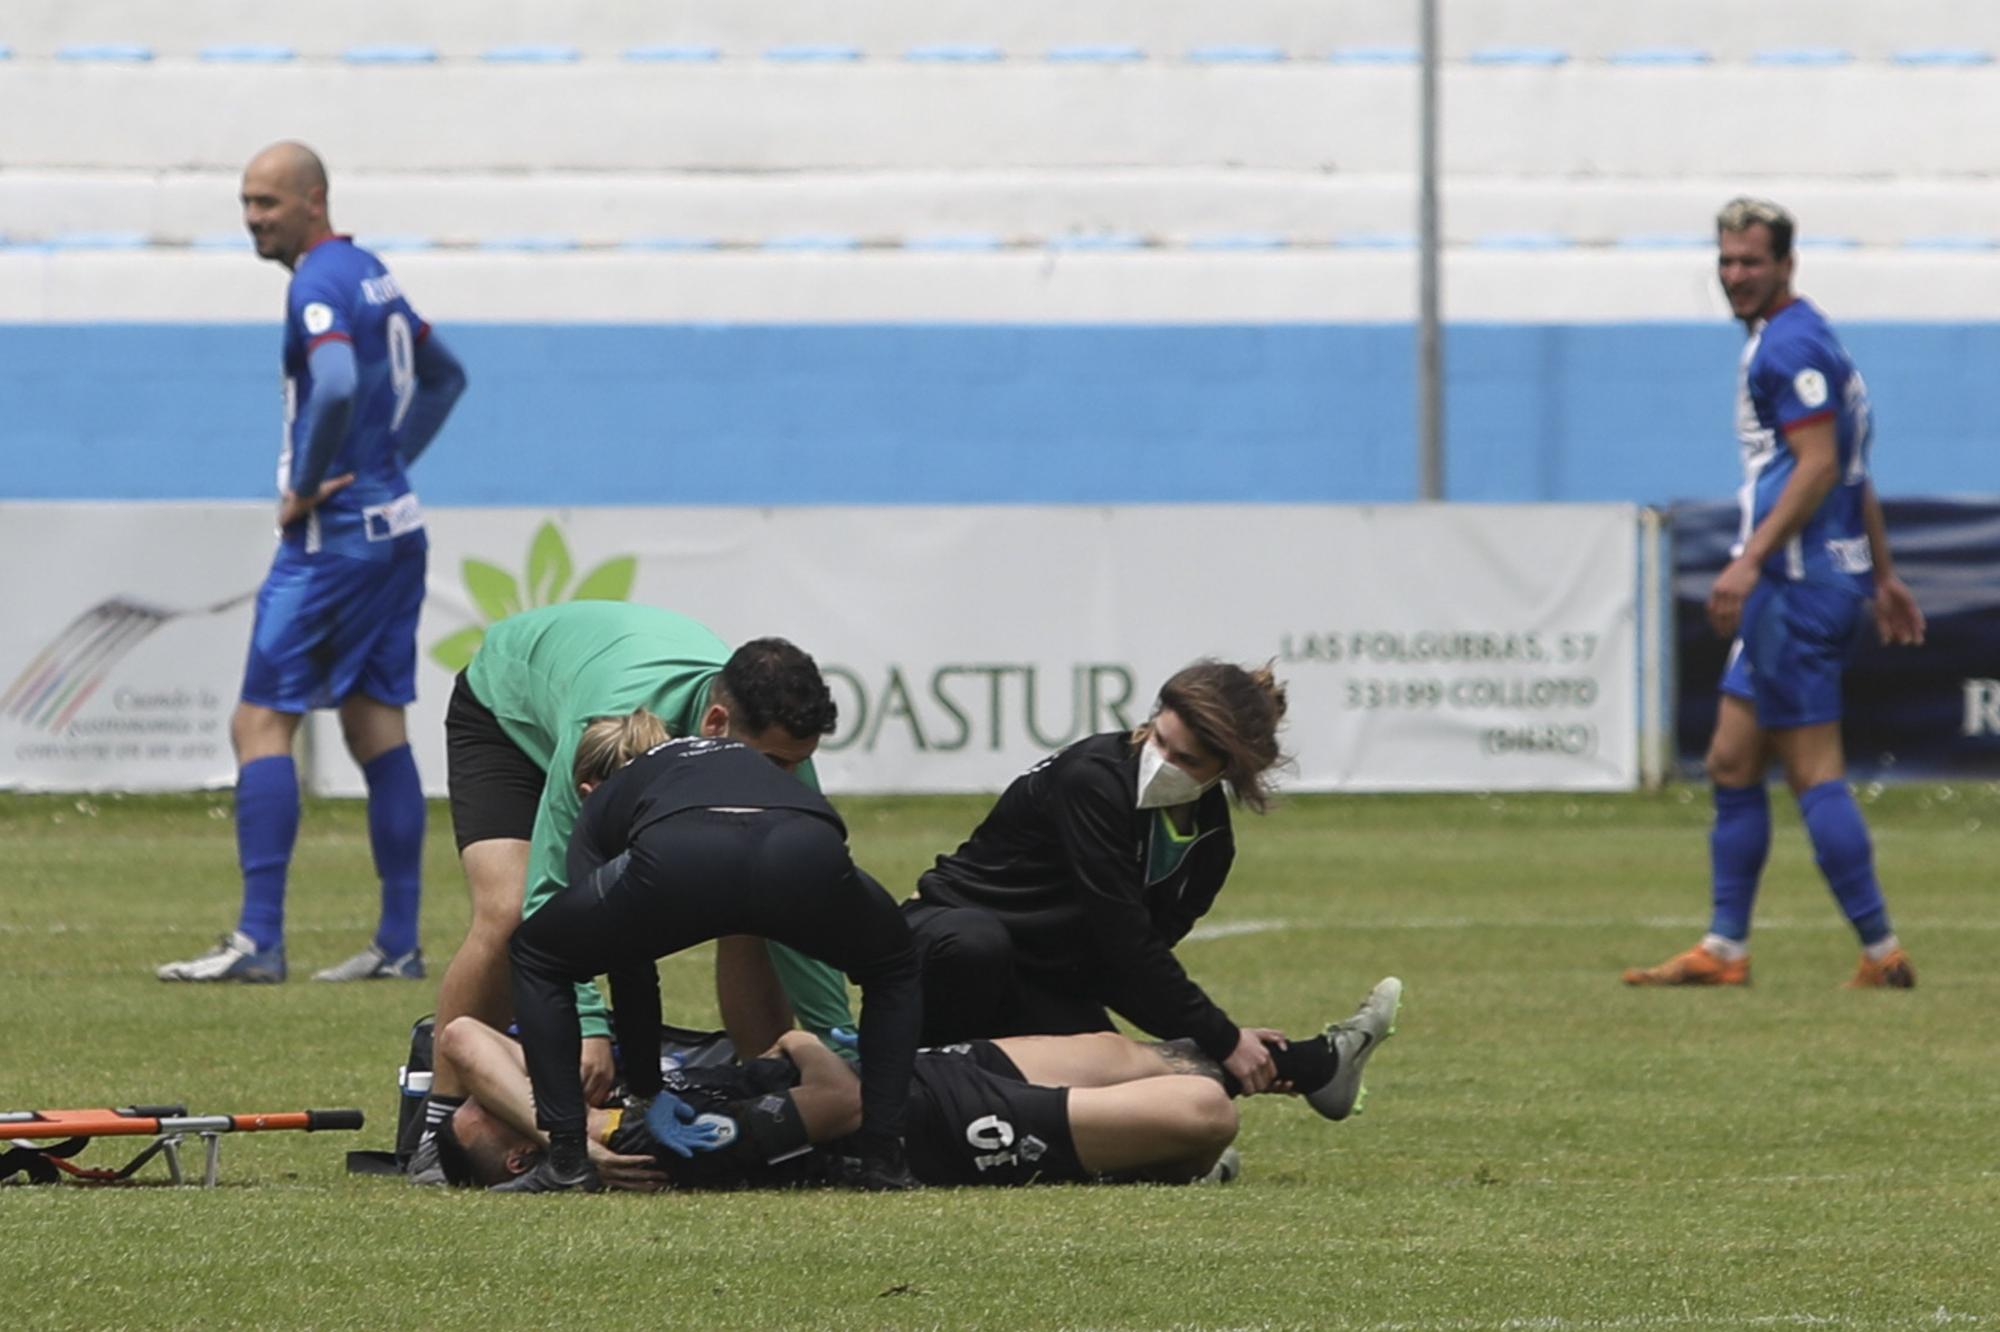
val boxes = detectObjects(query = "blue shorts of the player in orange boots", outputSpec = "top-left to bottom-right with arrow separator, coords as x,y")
1722,578 -> 1868,730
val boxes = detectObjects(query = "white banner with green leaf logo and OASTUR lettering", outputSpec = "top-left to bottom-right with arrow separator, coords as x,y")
318,506 -> 1636,792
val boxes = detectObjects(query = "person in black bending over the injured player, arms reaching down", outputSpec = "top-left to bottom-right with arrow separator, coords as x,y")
500,738 -> 922,1192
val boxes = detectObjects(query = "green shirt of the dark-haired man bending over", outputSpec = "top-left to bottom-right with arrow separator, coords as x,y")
466,602 -> 846,1034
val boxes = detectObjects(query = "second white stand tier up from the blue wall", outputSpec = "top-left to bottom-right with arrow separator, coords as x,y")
0,169 -> 2000,248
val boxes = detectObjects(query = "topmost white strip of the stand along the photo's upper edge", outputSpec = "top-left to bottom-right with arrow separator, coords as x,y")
11,0 -> 2000,60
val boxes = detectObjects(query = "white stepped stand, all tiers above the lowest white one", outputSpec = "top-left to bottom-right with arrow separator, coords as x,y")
0,0 -> 2000,318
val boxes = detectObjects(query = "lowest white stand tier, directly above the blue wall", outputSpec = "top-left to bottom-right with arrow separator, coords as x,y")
15,246 -> 2000,320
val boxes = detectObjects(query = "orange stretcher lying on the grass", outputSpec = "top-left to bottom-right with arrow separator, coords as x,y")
0,1106 -> 362,1188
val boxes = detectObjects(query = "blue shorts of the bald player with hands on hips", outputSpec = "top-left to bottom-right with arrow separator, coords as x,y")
242,532 -> 430,712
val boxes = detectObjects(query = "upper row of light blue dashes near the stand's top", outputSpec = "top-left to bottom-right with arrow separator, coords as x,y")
0,42 -> 1994,66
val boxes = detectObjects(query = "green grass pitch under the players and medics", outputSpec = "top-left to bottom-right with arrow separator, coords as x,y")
0,784 -> 2000,1332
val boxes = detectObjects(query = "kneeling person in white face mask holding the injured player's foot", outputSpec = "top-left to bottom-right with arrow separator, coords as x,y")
904,660 -> 1394,1096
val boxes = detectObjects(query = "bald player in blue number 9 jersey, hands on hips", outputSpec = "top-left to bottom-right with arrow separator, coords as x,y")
158,144 -> 466,982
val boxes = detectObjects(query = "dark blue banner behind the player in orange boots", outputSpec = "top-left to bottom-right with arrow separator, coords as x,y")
1670,500 -> 2000,780
